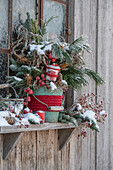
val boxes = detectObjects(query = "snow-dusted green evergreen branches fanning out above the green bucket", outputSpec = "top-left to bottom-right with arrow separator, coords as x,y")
9,13 -> 104,95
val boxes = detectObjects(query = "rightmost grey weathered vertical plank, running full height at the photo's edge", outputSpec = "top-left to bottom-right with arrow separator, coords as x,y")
96,0 -> 113,170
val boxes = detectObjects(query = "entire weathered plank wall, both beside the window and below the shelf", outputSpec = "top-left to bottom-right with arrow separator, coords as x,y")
0,0 -> 113,170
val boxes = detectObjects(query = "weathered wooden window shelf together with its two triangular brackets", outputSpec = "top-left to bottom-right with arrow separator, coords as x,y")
0,123 -> 75,159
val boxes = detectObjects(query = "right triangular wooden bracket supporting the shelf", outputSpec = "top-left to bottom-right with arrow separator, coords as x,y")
58,128 -> 75,150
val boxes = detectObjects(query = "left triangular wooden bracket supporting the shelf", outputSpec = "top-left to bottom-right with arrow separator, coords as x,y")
3,133 -> 23,159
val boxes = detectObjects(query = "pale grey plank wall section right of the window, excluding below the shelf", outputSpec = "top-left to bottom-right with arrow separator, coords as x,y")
73,0 -> 113,170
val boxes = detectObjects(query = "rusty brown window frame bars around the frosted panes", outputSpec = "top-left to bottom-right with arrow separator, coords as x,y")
0,0 -> 69,55
